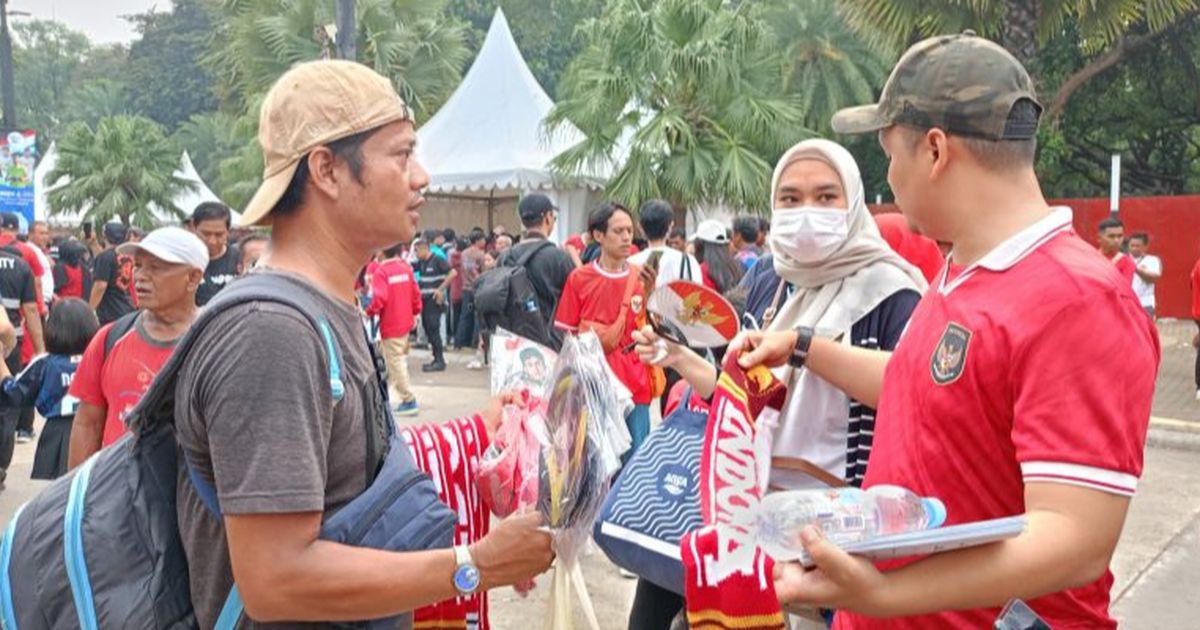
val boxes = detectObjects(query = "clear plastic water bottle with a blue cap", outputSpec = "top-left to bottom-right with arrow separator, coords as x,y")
752,486 -> 946,559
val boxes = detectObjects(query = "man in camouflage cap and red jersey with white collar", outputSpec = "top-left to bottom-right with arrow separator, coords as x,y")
731,32 -> 1160,629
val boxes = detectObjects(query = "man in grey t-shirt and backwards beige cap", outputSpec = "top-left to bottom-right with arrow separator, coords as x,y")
175,61 -> 552,628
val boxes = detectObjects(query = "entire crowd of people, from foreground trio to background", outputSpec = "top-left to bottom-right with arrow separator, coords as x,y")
0,34 -> 1166,630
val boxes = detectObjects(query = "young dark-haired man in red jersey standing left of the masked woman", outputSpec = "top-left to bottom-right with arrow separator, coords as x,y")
554,202 -> 652,461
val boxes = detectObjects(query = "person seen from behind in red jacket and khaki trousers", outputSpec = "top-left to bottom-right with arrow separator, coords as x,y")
367,245 -> 421,415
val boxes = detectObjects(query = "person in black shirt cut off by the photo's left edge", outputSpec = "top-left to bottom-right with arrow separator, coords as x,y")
0,247 -> 46,487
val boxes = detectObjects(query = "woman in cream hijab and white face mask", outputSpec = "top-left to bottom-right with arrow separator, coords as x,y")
629,139 -> 926,630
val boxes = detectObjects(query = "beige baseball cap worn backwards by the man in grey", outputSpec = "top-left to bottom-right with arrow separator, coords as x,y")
240,60 -> 413,227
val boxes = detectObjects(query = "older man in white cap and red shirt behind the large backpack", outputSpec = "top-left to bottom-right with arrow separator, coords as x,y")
67,228 -> 209,468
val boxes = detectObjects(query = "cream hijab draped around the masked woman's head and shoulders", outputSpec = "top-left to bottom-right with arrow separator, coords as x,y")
768,139 -> 928,337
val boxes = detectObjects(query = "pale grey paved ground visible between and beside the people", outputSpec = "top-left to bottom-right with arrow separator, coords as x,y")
0,331 -> 1200,630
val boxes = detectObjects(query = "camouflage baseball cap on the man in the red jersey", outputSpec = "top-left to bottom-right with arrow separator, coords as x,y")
833,31 -> 1042,140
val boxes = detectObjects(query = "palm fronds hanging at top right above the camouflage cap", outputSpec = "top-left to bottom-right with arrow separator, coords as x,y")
840,0 -> 1200,121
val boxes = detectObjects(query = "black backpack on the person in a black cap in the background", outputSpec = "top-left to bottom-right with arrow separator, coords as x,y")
475,241 -> 557,348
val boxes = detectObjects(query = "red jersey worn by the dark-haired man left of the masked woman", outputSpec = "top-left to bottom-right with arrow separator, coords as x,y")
554,262 -> 650,404
